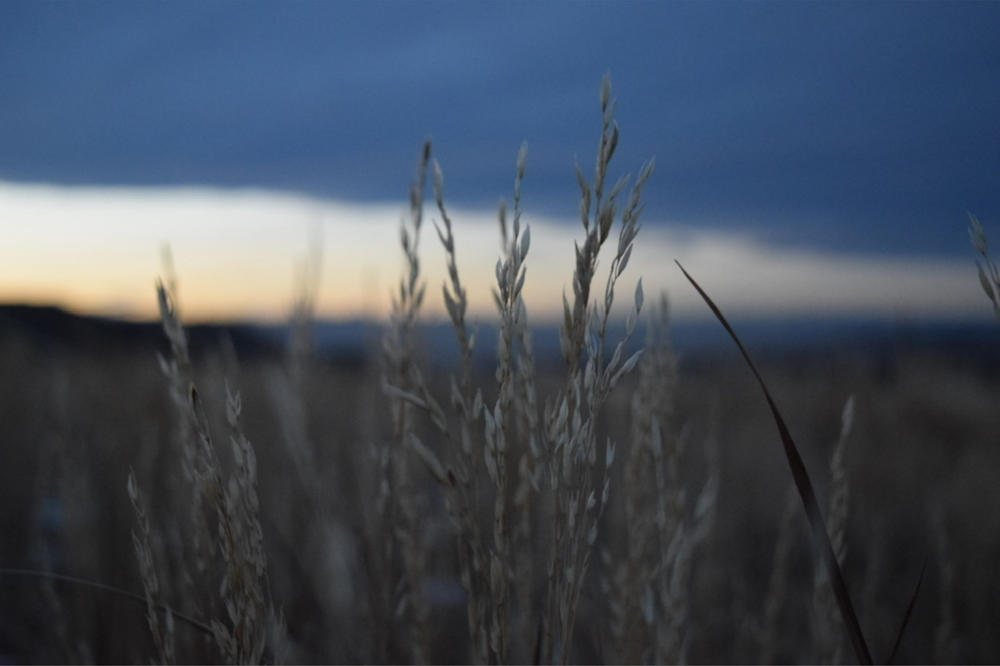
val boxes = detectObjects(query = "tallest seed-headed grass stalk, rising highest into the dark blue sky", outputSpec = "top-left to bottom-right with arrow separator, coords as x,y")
543,70 -> 653,663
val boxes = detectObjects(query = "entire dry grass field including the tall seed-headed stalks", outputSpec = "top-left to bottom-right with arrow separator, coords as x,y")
0,80 -> 1000,663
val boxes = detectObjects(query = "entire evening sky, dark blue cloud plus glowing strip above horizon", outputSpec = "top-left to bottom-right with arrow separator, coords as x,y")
0,1 -> 1000,320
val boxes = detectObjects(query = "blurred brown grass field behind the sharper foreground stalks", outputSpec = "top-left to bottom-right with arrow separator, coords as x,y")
0,309 -> 1000,663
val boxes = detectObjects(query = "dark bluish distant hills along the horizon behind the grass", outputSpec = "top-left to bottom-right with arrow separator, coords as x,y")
0,305 -> 1000,374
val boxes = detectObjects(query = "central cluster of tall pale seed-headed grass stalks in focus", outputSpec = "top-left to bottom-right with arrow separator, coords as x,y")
385,79 -> 652,663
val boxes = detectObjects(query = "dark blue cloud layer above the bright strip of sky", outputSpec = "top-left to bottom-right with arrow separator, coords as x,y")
0,2 -> 1000,256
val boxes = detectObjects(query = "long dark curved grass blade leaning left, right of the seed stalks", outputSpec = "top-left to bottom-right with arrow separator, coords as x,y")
675,261 -> 872,664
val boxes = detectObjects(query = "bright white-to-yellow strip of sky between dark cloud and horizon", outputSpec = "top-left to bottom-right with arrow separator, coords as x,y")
0,183 -> 989,321
